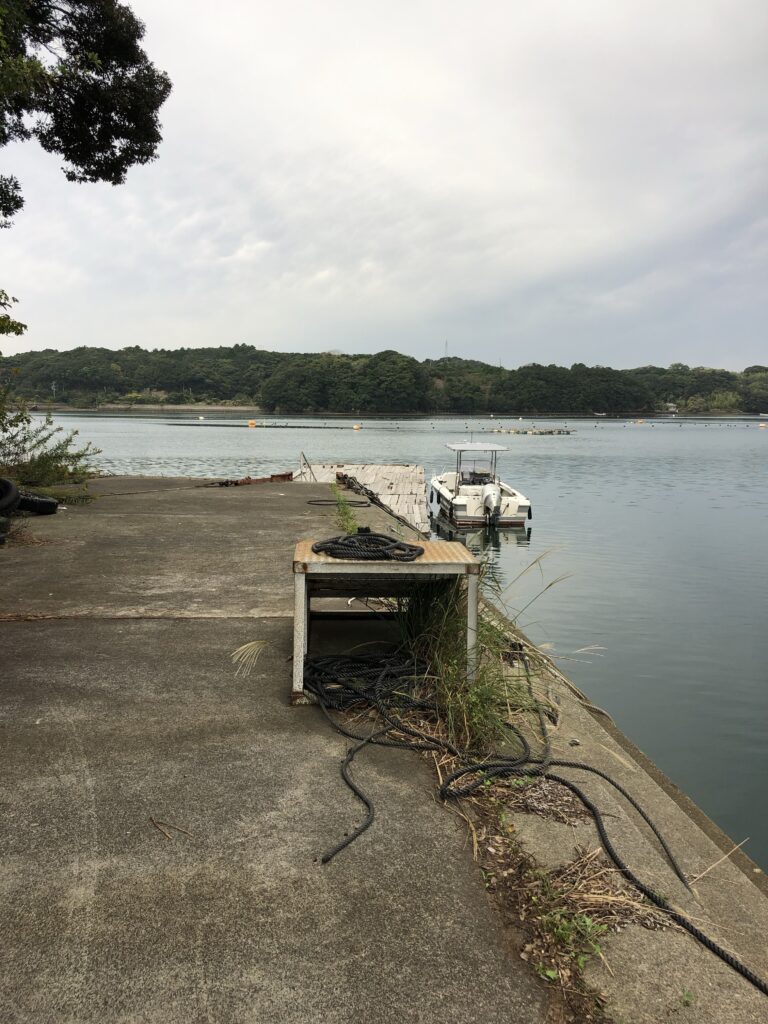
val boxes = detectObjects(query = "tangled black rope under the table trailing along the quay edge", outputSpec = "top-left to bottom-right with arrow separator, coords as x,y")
304,651 -> 768,995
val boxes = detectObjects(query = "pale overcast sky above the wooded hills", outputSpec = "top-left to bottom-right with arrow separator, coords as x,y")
0,0 -> 768,370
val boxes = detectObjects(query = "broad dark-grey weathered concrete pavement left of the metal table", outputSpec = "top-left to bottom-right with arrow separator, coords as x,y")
0,478 -> 548,1024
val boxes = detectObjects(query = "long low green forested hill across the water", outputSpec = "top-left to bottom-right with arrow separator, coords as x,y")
0,345 -> 768,416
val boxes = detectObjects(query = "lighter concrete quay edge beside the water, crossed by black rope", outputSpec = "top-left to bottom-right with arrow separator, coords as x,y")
514,689 -> 768,1024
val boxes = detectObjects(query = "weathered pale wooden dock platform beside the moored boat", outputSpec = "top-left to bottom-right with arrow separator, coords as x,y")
294,462 -> 429,534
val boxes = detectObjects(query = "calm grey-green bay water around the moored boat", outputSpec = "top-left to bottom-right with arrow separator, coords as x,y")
46,414 -> 768,867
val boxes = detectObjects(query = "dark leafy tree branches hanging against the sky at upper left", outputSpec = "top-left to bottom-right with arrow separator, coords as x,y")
0,0 -> 171,334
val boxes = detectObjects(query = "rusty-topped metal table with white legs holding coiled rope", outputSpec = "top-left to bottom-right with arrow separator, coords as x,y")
291,541 -> 480,703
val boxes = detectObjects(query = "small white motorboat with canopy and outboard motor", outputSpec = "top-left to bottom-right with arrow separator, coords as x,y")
429,441 -> 531,529
